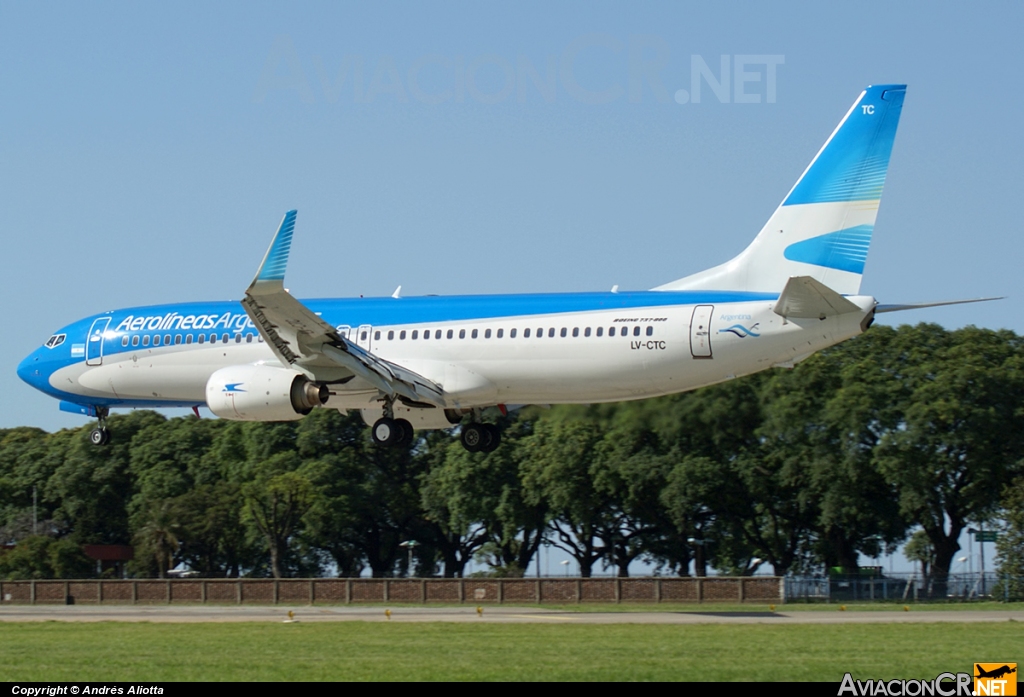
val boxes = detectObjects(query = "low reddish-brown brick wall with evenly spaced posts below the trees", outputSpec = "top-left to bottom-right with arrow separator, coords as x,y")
0,576 -> 783,605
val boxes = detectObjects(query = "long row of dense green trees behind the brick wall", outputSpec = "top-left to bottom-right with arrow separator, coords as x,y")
0,324 -> 1024,596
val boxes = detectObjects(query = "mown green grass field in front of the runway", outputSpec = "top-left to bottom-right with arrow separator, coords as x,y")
0,608 -> 1024,683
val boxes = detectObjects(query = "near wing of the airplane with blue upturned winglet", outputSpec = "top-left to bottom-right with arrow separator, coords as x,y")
242,211 -> 446,408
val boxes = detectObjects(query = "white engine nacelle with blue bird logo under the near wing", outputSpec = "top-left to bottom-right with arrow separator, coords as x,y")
206,364 -> 330,421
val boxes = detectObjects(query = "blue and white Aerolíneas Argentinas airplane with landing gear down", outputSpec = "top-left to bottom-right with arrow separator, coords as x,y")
17,85 -> 991,452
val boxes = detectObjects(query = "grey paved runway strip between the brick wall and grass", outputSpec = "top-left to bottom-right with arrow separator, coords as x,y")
0,605 -> 1024,624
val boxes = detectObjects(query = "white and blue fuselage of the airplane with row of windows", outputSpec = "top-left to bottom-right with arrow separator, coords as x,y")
18,291 -> 874,419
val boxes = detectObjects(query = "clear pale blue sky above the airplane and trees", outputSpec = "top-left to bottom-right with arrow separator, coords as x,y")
0,2 -> 1024,430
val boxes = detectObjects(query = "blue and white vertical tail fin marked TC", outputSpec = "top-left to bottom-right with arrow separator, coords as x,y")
654,85 -> 906,295
